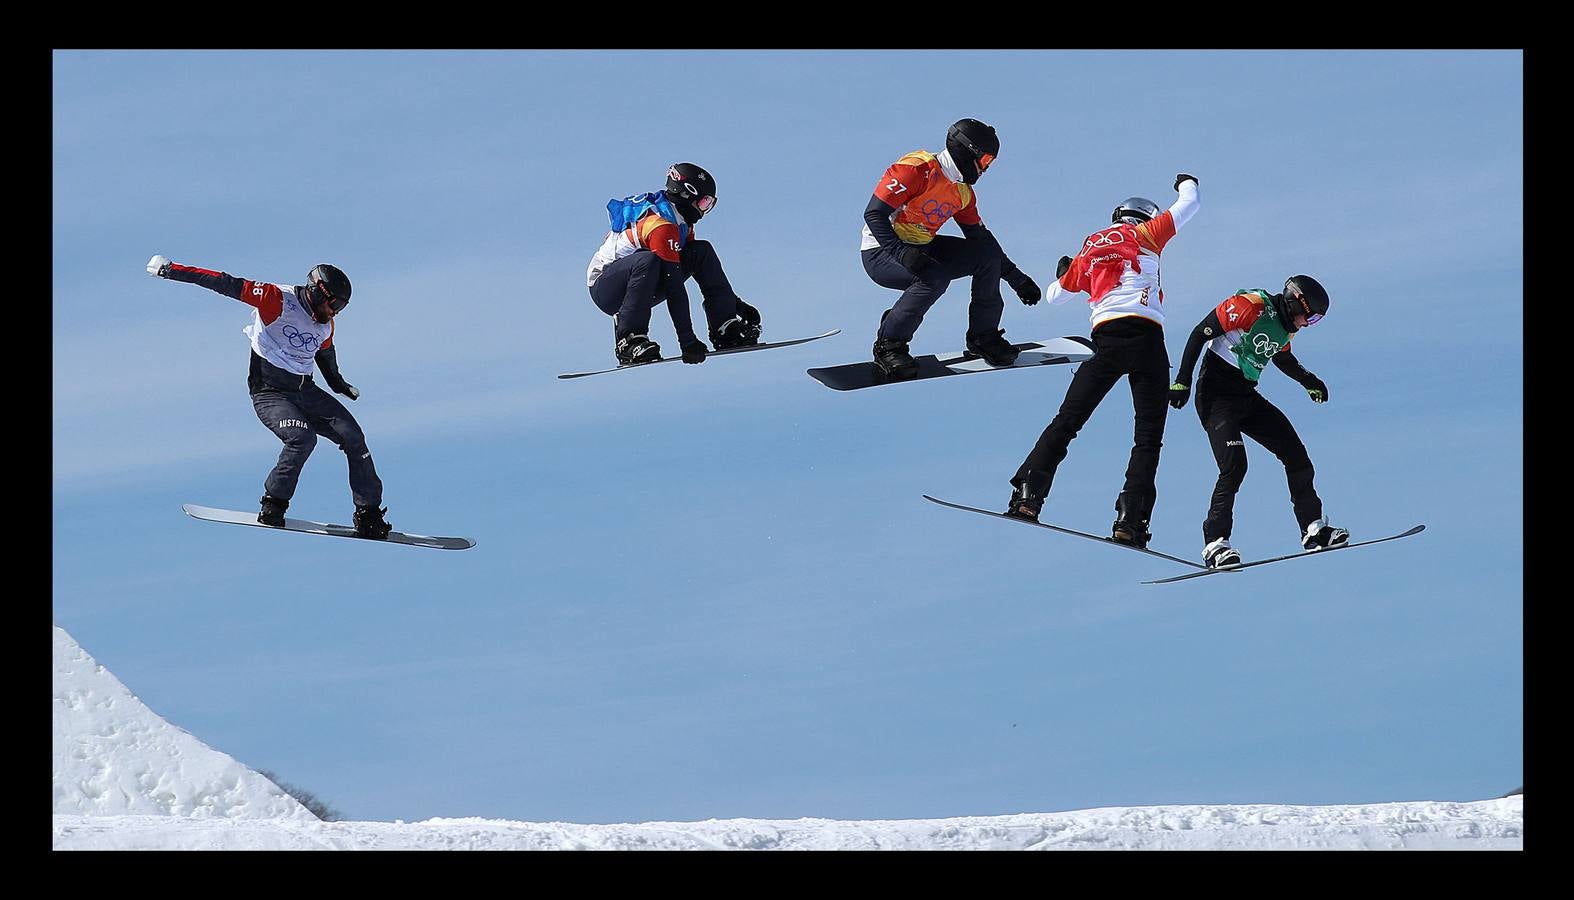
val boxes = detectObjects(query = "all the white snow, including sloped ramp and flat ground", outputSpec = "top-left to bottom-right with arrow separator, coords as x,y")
54,626 -> 1524,850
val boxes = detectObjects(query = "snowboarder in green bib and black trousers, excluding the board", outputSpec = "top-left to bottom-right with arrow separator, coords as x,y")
1169,275 -> 1350,568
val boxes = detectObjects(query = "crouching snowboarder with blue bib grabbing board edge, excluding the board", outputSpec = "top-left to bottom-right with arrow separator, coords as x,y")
586,162 -> 760,365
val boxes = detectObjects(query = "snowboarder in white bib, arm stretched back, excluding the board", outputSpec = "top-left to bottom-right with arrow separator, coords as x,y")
148,256 -> 392,540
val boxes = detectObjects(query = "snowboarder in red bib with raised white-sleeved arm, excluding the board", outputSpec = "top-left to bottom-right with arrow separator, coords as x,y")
1006,173 -> 1201,548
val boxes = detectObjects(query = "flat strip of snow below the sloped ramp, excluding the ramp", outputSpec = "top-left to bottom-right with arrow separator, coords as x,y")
55,796 -> 1524,850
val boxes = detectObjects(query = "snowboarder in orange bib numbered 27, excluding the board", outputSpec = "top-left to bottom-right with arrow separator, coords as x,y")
859,118 -> 1044,381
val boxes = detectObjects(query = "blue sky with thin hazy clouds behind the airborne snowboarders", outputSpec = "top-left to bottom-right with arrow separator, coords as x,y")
52,50 -> 1524,821
